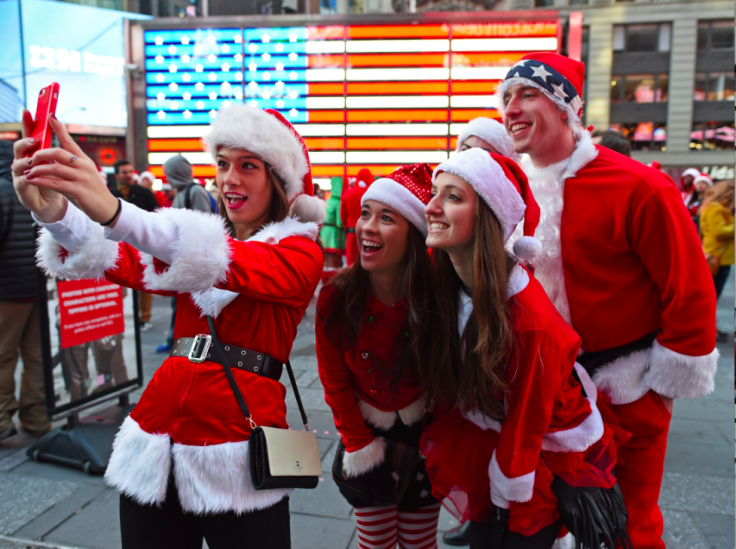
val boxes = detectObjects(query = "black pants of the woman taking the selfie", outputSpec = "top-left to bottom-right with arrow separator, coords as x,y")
120,479 -> 291,549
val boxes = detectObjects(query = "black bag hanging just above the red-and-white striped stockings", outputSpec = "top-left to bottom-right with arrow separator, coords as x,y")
332,439 -> 419,506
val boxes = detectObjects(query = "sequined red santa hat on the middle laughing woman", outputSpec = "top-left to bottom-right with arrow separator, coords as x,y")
360,165 -> 434,238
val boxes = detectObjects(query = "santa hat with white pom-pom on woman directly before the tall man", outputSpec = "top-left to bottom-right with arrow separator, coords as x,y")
432,148 -> 542,260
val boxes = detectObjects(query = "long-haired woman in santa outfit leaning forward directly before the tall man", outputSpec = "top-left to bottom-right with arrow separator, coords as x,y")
421,148 -> 616,549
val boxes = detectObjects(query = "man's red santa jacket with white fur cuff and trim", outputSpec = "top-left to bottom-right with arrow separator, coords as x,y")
511,132 -> 718,404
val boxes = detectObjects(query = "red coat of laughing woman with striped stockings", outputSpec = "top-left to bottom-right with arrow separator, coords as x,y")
315,285 -> 424,475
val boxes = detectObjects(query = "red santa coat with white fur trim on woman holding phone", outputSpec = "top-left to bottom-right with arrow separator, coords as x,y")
38,204 -> 324,513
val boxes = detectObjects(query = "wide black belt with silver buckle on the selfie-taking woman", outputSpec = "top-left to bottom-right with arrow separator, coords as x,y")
169,334 -> 284,381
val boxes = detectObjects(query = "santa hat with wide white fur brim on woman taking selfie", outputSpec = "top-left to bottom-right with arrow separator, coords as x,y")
202,104 -> 325,223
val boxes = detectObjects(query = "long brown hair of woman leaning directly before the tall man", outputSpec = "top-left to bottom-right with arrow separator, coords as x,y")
422,197 -> 516,419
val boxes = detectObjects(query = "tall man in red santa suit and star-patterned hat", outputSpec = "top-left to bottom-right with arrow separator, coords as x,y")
497,53 -> 718,549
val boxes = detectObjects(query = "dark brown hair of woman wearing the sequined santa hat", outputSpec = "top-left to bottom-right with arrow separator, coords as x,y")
317,223 -> 432,392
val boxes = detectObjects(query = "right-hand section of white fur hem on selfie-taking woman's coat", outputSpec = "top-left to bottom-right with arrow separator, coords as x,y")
173,441 -> 291,514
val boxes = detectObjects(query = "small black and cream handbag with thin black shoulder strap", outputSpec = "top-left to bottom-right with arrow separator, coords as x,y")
207,315 -> 322,490
